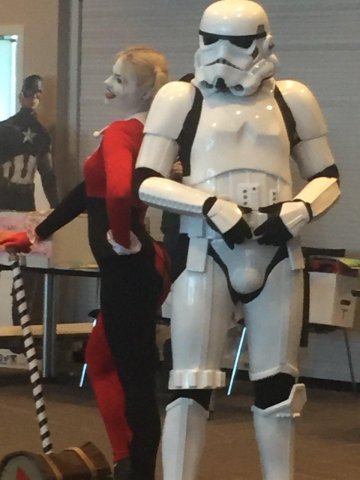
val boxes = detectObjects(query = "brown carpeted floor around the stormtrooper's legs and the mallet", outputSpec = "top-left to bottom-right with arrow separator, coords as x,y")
0,369 -> 360,480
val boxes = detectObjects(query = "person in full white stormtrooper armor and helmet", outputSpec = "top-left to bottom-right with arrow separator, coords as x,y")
135,0 -> 339,480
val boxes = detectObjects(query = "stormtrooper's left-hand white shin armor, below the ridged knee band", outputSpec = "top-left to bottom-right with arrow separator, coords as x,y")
162,397 -> 208,480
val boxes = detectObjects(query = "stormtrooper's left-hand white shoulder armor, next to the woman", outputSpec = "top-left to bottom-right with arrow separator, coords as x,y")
144,81 -> 196,140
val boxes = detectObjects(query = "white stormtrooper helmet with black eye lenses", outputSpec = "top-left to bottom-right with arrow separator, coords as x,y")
195,0 -> 277,96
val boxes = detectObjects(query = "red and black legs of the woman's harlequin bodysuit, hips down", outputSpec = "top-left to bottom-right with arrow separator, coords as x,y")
86,240 -> 168,480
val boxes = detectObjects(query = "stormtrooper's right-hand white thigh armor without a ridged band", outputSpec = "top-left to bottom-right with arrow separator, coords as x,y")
244,255 -> 303,381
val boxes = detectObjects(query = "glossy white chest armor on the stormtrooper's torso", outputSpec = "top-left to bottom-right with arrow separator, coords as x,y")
184,88 -> 291,204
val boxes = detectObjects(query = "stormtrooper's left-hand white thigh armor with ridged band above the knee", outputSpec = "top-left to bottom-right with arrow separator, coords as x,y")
169,251 -> 233,389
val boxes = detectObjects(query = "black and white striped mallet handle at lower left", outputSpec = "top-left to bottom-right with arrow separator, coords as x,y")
10,254 -> 52,454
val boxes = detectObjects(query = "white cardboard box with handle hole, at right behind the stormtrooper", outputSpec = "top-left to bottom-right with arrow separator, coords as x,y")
309,272 -> 358,328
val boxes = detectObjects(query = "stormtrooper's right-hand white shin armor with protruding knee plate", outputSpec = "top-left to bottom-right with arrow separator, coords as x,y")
252,384 -> 306,480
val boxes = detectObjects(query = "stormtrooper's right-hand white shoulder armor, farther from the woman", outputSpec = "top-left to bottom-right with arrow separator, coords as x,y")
276,80 -> 327,140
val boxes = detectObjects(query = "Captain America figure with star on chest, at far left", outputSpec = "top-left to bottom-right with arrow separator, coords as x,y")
0,75 -> 58,211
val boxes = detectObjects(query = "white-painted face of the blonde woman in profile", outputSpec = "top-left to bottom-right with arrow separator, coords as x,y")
104,58 -> 144,118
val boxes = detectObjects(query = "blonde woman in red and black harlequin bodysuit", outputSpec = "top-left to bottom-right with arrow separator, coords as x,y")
0,46 -> 169,480
